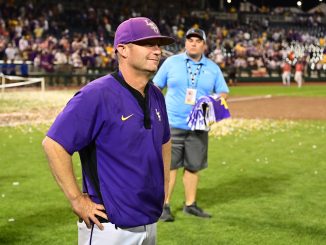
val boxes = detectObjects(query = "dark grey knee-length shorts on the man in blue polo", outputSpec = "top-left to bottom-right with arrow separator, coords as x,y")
171,128 -> 208,172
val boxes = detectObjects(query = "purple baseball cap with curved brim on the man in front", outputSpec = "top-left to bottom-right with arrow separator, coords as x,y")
114,17 -> 175,49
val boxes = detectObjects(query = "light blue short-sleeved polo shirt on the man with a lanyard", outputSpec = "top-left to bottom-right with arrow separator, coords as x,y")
153,53 -> 229,130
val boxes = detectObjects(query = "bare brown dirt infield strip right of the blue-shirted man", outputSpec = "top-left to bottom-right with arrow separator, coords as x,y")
228,96 -> 326,120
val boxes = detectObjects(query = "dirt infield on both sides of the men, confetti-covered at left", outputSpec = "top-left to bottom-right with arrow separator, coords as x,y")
0,94 -> 326,126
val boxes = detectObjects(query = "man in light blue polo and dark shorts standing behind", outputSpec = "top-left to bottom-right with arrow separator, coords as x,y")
153,29 -> 229,221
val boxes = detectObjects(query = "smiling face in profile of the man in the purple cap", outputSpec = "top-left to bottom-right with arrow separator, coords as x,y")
127,40 -> 162,73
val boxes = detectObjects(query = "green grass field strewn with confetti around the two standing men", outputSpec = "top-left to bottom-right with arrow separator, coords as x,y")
0,86 -> 326,245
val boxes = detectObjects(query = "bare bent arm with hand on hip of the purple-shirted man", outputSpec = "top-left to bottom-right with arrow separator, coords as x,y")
42,137 -> 108,229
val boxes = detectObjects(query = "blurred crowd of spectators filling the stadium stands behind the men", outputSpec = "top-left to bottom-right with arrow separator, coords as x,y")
0,0 -> 326,78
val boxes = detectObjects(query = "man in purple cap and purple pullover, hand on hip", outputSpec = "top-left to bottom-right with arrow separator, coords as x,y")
43,17 -> 174,245
